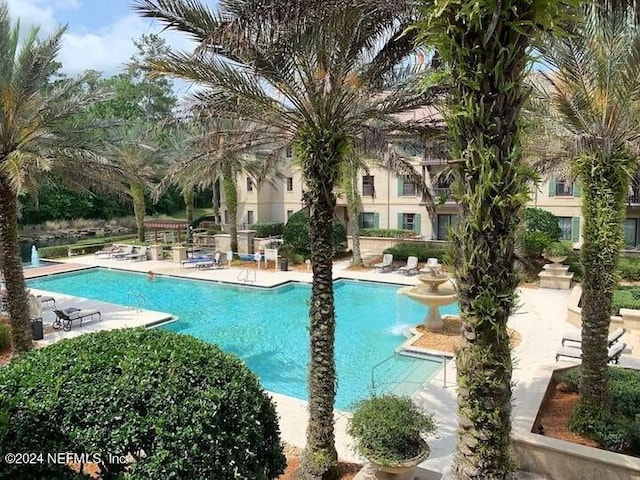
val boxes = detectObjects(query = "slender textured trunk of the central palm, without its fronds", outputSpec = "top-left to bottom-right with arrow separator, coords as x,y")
300,138 -> 338,480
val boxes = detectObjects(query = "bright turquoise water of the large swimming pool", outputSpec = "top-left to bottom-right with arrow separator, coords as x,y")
27,269 -> 457,410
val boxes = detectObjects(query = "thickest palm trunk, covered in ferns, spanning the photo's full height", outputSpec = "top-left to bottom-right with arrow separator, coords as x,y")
419,0 -> 571,479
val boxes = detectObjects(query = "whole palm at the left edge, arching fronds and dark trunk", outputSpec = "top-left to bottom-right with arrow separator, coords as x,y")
0,1 -> 125,352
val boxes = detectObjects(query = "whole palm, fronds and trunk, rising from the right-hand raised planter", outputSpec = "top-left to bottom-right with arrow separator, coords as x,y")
540,7 -> 640,408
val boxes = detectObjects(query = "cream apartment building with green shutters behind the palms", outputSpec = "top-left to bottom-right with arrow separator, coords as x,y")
221,140 -> 640,250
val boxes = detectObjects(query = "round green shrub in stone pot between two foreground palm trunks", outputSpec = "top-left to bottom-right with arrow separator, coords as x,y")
348,394 -> 436,475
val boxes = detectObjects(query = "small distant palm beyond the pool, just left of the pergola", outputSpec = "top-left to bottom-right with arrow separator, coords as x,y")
107,121 -> 160,242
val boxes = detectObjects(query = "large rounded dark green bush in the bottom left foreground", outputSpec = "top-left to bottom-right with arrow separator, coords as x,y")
0,329 -> 285,480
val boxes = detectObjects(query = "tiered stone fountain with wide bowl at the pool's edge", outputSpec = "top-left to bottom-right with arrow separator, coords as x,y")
398,258 -> 458,332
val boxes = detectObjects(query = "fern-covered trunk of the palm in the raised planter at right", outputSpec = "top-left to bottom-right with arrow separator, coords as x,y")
578,155 -> 629,408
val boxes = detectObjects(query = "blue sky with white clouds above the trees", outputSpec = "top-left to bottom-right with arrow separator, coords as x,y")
6,0 -> 210,76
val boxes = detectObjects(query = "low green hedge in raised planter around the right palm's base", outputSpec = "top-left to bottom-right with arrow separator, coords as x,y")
558,367 -> 640,455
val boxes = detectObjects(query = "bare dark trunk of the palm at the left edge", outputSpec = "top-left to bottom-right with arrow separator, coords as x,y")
0,178 -> 33,352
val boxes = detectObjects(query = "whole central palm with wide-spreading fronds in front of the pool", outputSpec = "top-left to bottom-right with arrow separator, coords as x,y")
136,0 -> 438,478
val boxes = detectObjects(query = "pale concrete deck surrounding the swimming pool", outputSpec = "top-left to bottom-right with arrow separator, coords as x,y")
25,255 -> 640,478
